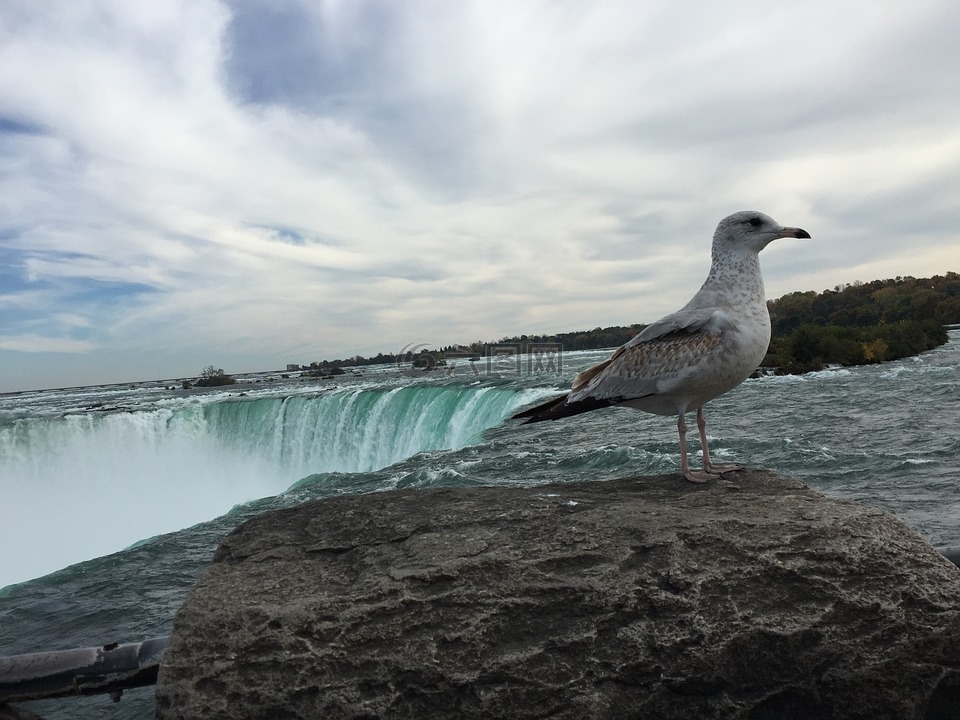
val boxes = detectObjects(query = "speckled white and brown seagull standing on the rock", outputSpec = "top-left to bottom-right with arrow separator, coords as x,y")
513,210 -> 810,483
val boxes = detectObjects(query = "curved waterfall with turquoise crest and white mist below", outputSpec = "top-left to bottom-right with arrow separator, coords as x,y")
0,385 -> 524,587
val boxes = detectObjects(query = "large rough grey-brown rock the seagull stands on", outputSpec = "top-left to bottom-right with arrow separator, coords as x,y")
157,471 -> 960,720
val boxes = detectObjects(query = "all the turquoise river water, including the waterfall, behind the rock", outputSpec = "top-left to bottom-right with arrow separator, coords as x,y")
0,331 -> 960,718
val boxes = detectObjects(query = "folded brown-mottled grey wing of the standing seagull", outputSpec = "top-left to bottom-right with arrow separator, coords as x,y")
567,308 -> 731,404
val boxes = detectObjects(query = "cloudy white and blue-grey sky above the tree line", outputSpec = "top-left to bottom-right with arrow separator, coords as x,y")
0,0 -> 960,391
